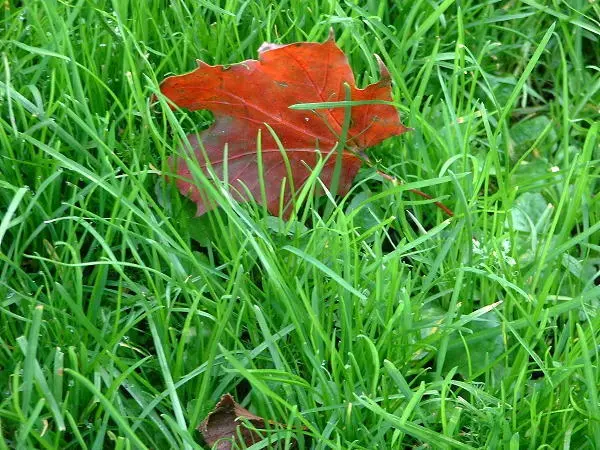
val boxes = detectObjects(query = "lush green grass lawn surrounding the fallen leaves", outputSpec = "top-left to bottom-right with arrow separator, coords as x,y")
0,0 -> 600,449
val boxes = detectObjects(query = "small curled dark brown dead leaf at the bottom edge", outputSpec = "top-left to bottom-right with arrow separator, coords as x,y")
198,394 -> 290,450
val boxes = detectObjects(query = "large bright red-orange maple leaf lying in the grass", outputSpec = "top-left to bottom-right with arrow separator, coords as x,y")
160,38 -> 406,215
